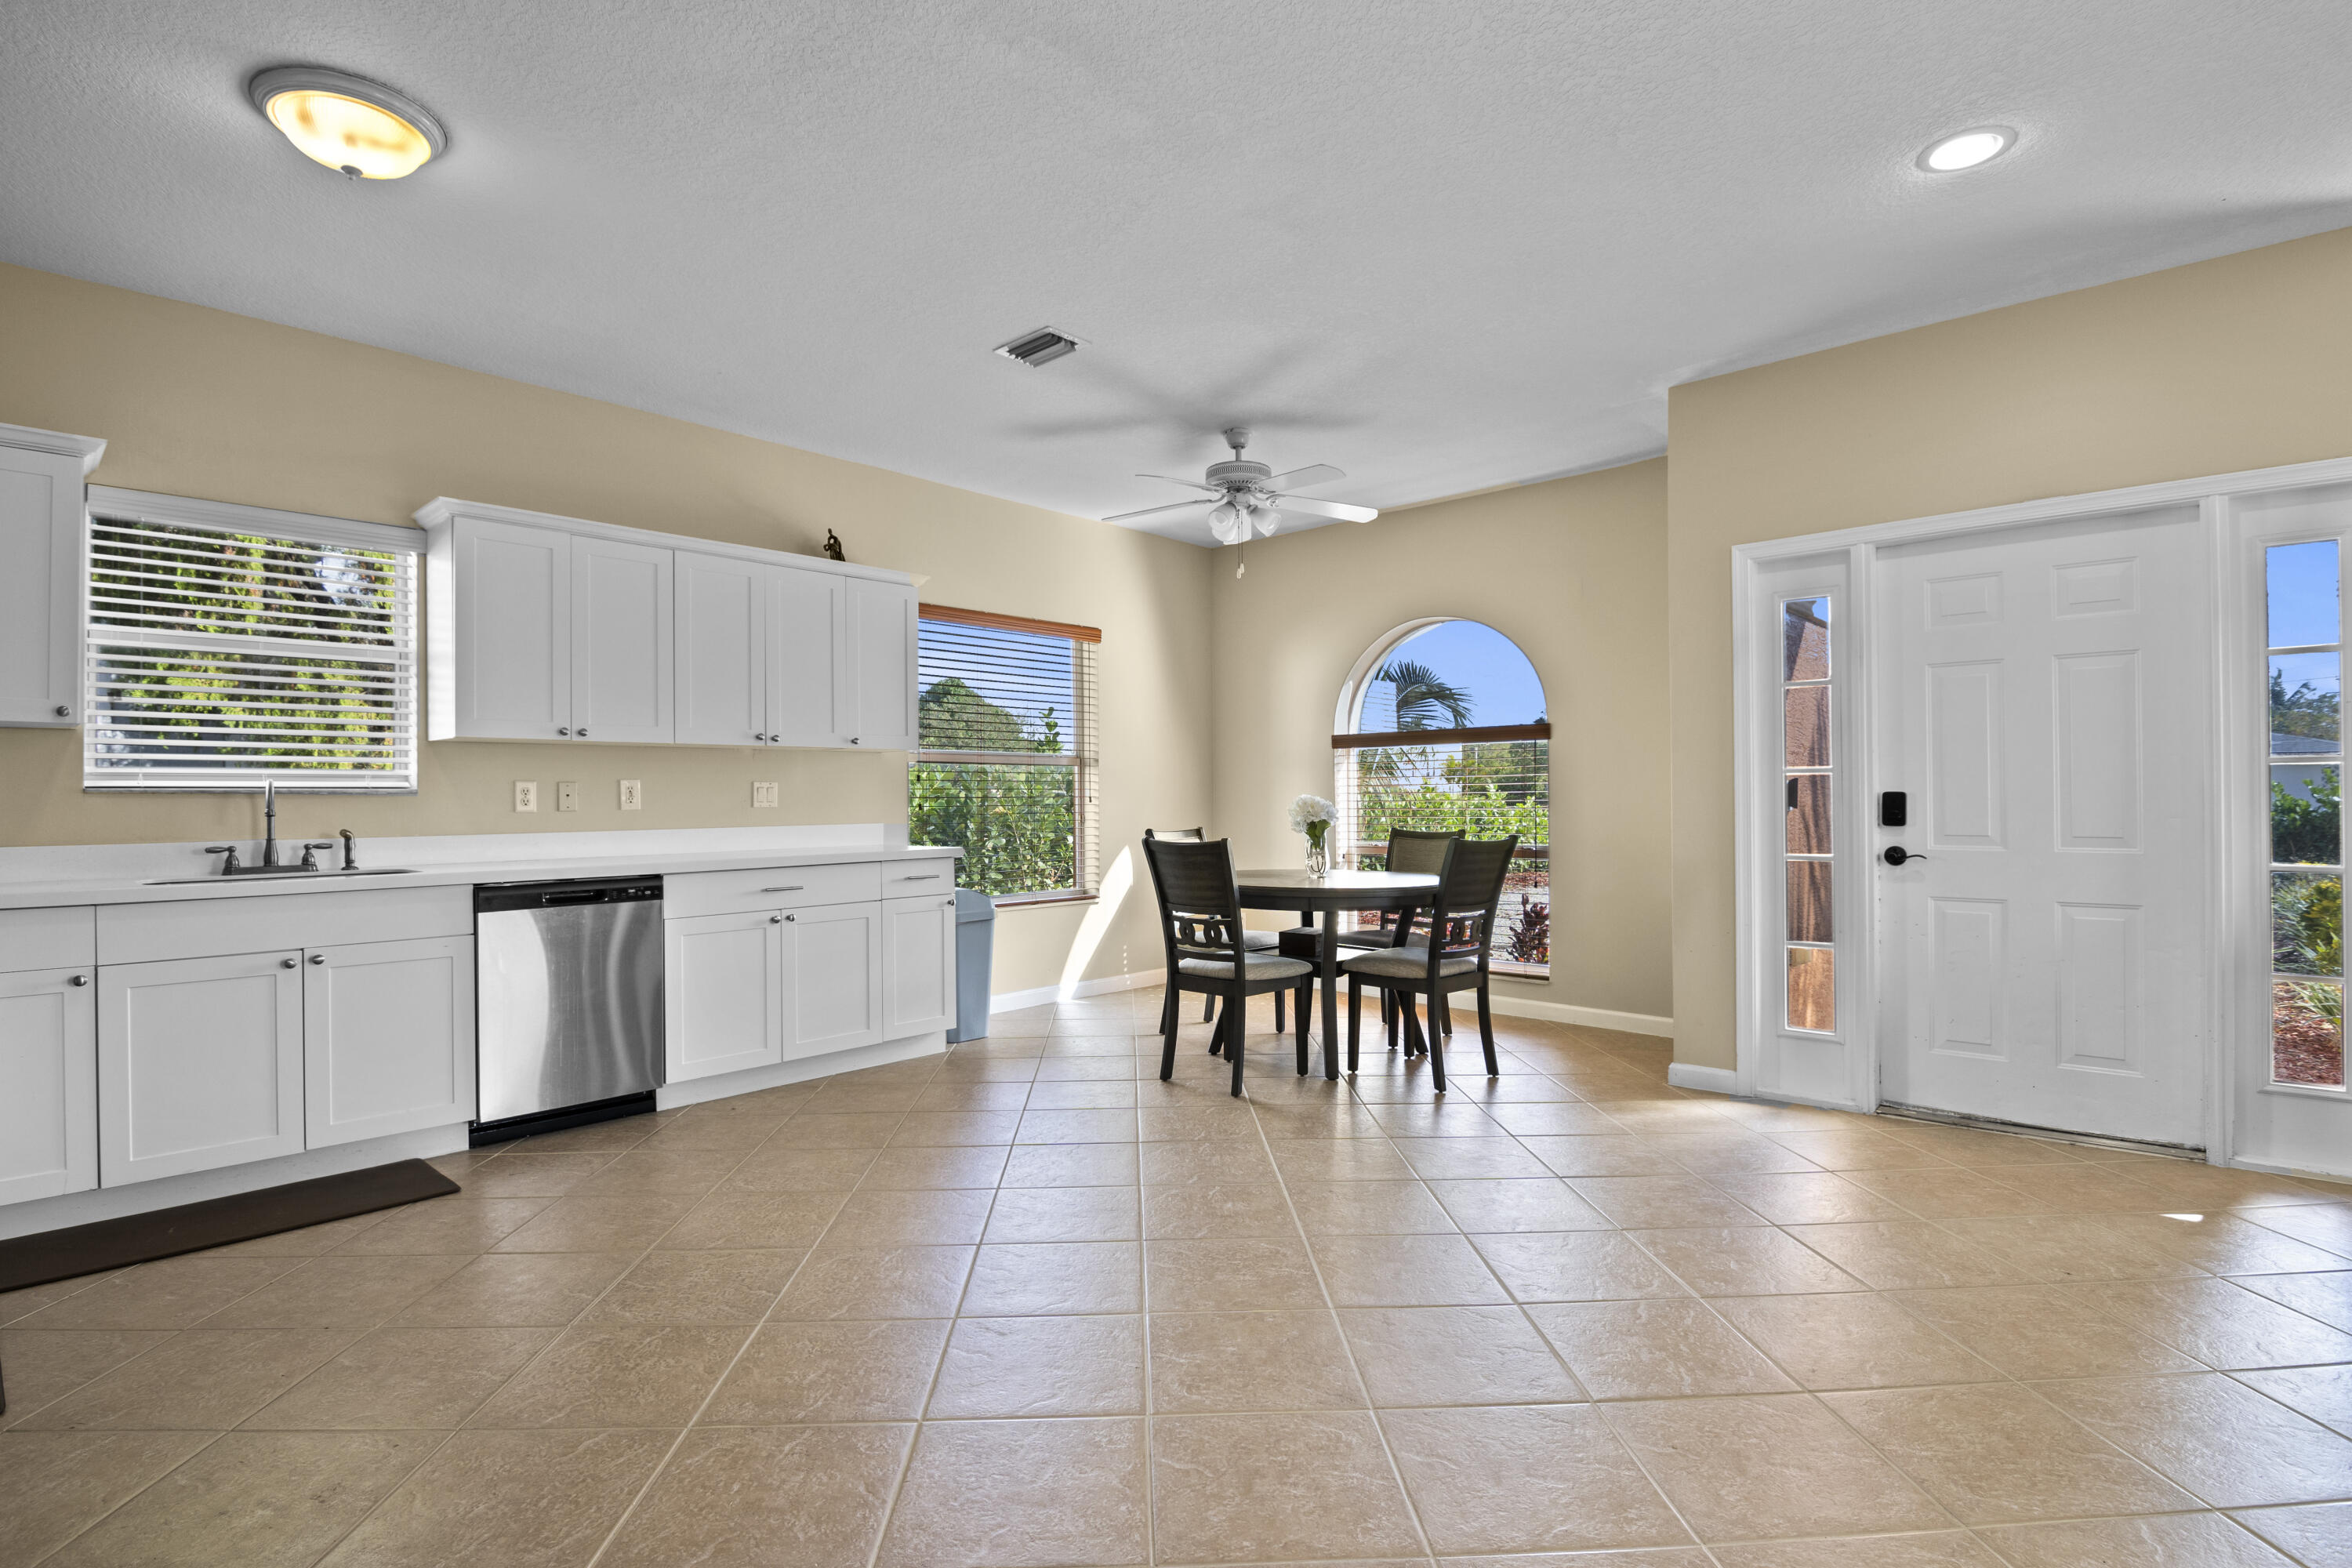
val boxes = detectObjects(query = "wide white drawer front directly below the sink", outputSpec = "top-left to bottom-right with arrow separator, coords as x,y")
99,884 -> 473,964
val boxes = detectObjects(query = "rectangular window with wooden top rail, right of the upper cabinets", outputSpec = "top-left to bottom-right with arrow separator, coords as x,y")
908,604 -> 1103,902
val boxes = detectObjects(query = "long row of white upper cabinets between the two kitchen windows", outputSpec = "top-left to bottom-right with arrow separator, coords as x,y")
416,499 -> 915,750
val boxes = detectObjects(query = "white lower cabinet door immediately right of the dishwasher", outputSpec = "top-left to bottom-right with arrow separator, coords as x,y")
661,909 -> 783,1083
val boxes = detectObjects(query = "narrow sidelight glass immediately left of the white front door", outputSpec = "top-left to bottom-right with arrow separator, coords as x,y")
1780,597 -> 1837,1032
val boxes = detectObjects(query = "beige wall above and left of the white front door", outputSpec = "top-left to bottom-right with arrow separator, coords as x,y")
1668,230 -> 2352,1067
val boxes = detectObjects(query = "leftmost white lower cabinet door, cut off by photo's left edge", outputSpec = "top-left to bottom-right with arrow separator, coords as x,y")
0,968 -> 99,1203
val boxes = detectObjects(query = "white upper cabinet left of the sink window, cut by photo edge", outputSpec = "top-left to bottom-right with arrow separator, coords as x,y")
0,426 -> 106,729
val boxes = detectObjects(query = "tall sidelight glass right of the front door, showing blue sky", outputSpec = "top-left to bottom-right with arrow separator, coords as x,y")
2263,539 -> 2345,1088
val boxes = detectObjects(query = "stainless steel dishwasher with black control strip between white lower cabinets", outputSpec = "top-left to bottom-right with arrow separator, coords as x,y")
473,877 -> 661,1147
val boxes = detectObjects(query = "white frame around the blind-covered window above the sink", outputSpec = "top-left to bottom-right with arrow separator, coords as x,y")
78,485 -> 426,794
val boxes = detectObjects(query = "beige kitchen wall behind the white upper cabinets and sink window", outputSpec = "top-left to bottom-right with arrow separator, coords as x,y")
0,266 -> 1209,989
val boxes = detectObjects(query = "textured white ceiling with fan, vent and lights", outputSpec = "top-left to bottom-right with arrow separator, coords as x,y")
0,0 -> 2352,541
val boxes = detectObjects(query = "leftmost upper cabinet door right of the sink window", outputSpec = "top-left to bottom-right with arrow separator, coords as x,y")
454,520 -> 572,741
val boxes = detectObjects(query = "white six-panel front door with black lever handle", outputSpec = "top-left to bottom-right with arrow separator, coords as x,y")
1867,506 -> 2216,1145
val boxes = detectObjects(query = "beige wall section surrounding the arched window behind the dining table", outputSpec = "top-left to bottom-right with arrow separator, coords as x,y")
1200,461 -> 1670,1018
